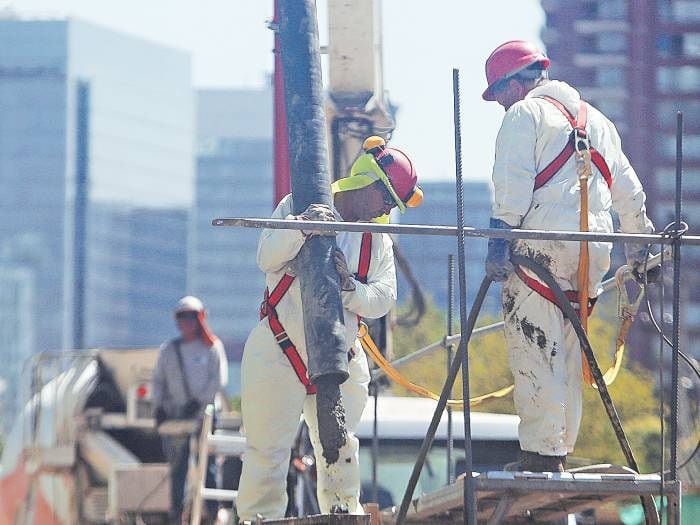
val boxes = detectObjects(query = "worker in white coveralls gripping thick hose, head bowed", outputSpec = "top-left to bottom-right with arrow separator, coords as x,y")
236,137 -> 423,521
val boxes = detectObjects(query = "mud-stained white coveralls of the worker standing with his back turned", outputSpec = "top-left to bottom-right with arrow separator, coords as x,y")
493,81 -> 653,456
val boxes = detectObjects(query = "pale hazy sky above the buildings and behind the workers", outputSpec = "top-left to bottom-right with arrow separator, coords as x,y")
0,0 -> 543,180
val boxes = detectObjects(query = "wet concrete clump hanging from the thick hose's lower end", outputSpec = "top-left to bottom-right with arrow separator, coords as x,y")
316,380 -> 347,465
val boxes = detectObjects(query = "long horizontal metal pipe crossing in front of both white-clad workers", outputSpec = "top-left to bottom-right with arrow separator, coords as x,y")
212,217 -> 700,246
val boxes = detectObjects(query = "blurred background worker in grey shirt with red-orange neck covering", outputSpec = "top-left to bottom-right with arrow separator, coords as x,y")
153,295 -> 228,524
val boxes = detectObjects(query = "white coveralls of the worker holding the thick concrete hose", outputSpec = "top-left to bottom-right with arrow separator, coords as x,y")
236,195 -> 396,520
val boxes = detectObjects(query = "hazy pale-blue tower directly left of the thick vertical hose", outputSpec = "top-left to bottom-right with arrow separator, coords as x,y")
188,88 -> 273,359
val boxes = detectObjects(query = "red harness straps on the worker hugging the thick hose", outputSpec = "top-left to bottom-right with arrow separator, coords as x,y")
260,232 -> 372,394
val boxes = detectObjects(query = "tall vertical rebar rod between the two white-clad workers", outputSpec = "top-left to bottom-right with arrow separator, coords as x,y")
452,69 -> 476,525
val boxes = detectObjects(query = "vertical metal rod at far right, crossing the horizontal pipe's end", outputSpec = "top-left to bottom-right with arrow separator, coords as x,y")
668,111 -> 683,523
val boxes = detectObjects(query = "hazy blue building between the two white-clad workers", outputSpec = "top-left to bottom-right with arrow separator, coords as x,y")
396,182 -> 500,319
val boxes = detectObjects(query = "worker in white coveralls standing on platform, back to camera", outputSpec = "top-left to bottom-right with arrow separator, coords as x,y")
483,40 -> 654,471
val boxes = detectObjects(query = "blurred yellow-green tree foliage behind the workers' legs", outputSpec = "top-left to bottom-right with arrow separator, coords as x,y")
392,294 -> 661,472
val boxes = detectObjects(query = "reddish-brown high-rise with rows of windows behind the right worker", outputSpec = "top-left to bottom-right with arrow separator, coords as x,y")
542,0 -> 700,353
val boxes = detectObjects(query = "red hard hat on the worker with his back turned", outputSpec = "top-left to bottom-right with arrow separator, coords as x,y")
481,40 -> 549,100
